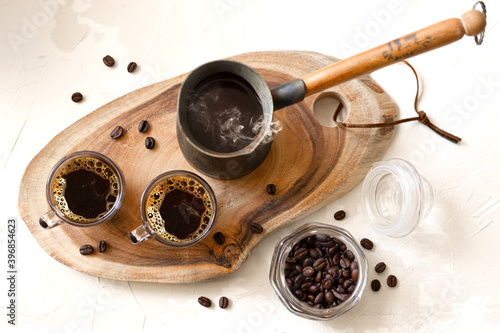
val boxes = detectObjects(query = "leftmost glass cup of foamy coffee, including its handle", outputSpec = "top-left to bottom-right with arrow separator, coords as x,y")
39,151 -> 125,228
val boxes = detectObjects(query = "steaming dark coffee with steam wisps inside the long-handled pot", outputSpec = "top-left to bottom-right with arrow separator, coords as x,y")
188,74 -> 282,152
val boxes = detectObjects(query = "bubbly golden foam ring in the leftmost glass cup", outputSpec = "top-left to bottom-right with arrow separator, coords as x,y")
52,157 -> 120,223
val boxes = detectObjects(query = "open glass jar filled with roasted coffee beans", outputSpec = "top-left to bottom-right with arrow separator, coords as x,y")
270,223 -> 368,320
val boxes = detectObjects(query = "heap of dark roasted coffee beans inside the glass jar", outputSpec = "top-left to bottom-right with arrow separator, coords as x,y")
285,234 -> 359,309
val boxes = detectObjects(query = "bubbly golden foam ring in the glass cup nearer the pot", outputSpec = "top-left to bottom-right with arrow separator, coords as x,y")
146,176 -> 213,243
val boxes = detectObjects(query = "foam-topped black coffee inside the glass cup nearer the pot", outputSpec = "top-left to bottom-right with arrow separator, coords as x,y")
146,176 -> 214,243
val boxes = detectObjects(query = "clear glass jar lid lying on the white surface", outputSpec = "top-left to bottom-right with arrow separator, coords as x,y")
361,158 -> 434,237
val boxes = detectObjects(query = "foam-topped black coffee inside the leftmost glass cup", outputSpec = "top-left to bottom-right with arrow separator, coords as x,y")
52,157 -> 120,222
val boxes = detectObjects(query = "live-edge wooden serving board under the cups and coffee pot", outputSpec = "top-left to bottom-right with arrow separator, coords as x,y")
19,51 -> 398,283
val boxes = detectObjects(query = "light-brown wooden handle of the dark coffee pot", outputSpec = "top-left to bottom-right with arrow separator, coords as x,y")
302,10 -> 486,96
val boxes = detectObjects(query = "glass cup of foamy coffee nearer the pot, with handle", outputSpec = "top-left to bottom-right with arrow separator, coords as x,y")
129,170 -> 217,247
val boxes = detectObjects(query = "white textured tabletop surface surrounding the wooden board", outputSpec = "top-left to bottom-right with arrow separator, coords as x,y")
0,0 -> 500,332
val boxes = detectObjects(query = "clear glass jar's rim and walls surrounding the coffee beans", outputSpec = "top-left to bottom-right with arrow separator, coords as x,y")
269,222 -> 368,320
